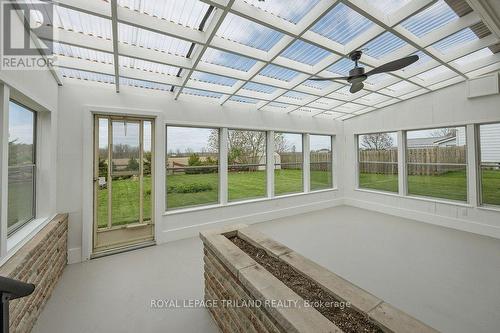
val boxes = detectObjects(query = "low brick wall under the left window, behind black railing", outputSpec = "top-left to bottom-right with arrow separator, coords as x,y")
0,214 -> 68,332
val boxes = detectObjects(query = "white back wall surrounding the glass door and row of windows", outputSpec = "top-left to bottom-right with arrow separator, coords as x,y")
57,80 -> 342,262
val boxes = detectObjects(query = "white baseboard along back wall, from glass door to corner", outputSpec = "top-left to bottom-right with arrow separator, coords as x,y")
156,199 -> 343,244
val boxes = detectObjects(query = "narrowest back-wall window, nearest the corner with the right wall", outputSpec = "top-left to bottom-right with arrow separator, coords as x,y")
309,135 -> 333,191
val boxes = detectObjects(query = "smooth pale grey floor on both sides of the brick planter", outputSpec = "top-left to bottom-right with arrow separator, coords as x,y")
33,206 -> 500,333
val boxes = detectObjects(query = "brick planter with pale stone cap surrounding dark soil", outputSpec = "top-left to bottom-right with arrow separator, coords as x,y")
200,225 -> 437,333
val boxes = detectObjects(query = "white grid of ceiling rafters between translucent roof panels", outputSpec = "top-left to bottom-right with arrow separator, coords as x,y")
33,0 -> 500,119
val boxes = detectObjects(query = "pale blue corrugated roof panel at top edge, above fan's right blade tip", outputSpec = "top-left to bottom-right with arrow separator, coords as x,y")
401,0 -> 458,37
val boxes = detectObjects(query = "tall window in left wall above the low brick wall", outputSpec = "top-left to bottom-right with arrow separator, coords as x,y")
7,102 -> 36,234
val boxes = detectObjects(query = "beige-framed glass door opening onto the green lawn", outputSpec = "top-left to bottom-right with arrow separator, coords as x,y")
93,116 -> 154,253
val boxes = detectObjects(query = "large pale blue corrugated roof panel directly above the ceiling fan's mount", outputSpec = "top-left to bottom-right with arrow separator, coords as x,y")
311,3 -> 373,45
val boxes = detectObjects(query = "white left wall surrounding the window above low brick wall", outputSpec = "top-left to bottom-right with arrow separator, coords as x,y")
0,7 -> 58,264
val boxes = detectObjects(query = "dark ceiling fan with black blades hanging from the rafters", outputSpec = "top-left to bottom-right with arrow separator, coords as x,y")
311,51 -> 418,94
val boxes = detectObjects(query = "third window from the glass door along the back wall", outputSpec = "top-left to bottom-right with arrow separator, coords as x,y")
274,132 -> 304,195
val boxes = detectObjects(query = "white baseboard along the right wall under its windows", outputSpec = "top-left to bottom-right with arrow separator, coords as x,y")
343,198 -> 500,239
